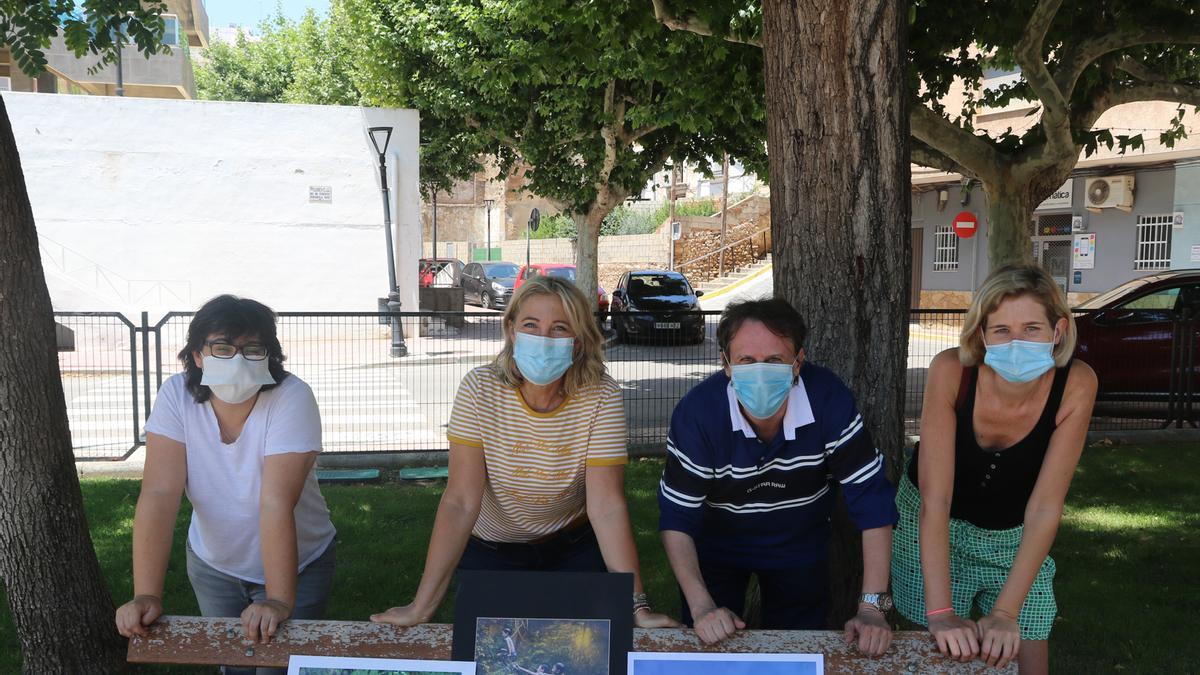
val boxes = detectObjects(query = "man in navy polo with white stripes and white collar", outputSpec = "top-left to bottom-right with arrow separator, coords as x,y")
659,299 -> 898,656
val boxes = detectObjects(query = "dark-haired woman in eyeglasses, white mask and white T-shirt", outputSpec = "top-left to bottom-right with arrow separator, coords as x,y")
116,295 -> 335,673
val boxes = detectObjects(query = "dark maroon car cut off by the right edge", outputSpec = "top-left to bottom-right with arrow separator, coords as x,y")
1075,269 -> 1200,401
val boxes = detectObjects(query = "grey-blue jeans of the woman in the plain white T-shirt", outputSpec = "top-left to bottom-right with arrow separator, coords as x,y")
187,542 -> 337,675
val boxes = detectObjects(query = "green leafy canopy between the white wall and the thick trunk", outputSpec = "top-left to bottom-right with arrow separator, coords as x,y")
337,0 -> 764,208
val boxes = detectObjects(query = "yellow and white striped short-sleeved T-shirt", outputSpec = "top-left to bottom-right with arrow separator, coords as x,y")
446,365 -> 629,542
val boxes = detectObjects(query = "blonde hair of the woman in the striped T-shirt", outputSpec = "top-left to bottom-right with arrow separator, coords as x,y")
492,275 -> 605,396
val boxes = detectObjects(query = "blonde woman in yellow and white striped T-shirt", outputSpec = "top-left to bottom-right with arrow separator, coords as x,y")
371,276 -> 677,628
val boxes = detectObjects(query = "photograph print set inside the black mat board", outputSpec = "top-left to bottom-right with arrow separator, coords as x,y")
475,617 -> 612,675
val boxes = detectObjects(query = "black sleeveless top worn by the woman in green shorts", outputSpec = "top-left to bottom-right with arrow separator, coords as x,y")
908,363 -> 1070,530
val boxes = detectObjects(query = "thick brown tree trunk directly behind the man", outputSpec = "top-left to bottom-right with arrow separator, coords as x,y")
763,0 -> 912,627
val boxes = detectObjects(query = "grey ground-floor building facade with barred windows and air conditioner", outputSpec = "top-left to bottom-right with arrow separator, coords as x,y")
912,150 -> 1200,309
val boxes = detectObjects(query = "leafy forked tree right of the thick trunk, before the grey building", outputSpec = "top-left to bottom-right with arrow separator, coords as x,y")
652,0 -> 1200,264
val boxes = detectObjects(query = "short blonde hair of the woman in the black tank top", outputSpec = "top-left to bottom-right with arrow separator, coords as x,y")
959,264 -> 1075,368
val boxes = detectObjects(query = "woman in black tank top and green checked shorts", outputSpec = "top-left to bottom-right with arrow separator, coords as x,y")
892,265 -> 1096,674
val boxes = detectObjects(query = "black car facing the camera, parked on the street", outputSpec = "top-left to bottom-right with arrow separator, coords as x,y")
610,269 -> 704,342
